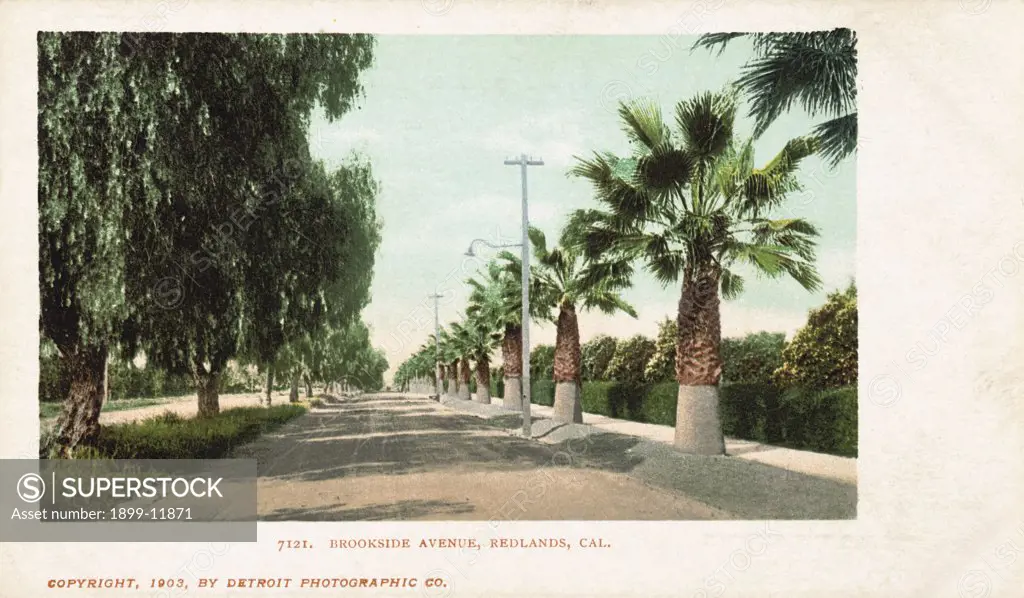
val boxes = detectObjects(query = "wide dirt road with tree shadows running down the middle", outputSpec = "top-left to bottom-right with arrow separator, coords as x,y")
228,394 -> 732,520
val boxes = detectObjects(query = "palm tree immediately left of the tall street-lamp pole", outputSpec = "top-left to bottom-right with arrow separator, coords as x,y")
466,261 -> 522,410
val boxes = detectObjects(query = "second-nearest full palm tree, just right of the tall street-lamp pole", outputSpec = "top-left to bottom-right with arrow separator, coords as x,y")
502,227 -> 637,423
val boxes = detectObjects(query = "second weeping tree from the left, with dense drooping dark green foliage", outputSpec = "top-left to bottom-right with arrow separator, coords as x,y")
118,34 -> 372,416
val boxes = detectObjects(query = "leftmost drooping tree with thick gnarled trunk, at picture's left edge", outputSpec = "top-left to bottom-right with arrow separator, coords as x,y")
37,32 -> 153,456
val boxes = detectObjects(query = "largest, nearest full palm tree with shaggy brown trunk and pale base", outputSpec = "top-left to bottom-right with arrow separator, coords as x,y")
569,92 -> 820,455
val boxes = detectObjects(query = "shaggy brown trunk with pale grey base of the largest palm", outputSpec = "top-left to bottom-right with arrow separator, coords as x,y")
675,266 -> 725,455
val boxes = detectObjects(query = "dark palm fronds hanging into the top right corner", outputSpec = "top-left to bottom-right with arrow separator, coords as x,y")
693,29 -> 857,167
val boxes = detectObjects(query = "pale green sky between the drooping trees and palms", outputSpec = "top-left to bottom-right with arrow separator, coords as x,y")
310,36 -> 856,375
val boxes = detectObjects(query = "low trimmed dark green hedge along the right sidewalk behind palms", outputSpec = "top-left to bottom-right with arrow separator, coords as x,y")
530,380 -> 857,457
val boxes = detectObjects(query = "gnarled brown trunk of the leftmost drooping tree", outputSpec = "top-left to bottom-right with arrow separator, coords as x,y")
54,346 -> 108,459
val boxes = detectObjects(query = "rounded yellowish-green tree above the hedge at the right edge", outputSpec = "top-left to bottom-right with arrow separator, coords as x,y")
775,283 -> 857,389
